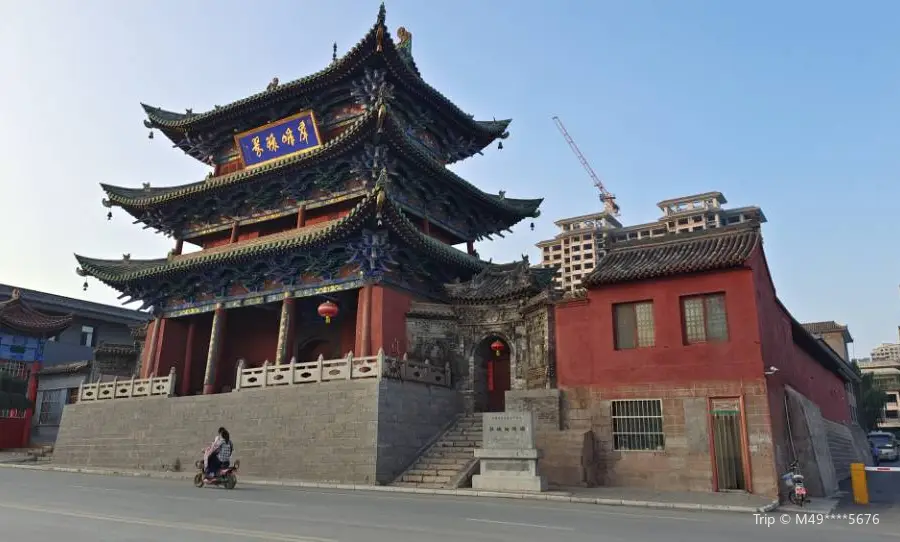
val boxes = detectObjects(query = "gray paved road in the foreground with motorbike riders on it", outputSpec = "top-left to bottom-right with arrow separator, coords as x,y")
0,468 -> 900,542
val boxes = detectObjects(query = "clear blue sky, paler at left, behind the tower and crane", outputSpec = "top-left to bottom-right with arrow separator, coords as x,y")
0,0 -> 900,356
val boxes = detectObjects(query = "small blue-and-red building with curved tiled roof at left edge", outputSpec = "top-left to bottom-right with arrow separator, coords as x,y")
0,290 -> 72,449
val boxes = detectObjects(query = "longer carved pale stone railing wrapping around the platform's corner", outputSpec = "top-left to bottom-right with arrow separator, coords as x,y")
234,350 -> 451,391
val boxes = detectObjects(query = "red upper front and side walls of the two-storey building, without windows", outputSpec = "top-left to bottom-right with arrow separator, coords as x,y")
556,249 -> 850,425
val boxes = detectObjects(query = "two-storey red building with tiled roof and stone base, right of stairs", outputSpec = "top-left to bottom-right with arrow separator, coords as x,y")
556,223 -> 858,495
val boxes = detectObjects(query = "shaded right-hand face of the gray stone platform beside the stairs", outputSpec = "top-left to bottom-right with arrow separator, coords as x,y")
377,380 -> 462,484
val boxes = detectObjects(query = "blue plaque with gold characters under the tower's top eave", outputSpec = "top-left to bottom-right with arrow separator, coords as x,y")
234,111 -> 322,167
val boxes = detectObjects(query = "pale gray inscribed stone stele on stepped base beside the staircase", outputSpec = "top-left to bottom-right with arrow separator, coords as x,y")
472,411 -> 547,491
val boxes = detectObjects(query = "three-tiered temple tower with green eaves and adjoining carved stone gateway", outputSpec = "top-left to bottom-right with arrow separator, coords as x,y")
76,5 -> 553,409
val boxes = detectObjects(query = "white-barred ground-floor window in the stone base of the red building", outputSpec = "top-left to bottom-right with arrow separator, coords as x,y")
612,399 -> 666,450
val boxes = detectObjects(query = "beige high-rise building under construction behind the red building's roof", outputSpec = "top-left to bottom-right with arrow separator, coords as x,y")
537,192 -> 766,293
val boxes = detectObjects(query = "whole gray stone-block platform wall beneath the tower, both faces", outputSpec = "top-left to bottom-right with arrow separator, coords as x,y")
54,379 -> 460,484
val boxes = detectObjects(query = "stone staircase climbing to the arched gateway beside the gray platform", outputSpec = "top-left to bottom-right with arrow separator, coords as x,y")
391,414 -> 482,488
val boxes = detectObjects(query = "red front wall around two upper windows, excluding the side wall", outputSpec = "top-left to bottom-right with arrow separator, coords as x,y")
556,269 -> 762,388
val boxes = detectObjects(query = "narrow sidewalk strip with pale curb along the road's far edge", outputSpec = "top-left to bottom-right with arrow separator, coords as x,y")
0,461 -> 778,513
